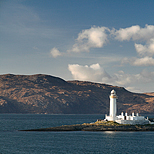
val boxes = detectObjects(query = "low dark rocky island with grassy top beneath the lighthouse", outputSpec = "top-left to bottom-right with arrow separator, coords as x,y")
20,121 -> 154,131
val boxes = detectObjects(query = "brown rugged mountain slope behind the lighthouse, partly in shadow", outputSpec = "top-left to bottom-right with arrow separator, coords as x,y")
0,74 -> 154,114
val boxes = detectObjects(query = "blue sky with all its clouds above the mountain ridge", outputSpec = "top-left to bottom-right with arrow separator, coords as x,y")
0,0 -> 154,93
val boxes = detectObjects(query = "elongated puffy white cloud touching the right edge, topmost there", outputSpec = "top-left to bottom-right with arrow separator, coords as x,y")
112,25 -> 154,41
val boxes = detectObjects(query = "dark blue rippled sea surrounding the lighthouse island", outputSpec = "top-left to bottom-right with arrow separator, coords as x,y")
0,114 -> 154,154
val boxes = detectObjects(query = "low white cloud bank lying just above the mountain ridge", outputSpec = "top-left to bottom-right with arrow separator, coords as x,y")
68,63 -> 154,92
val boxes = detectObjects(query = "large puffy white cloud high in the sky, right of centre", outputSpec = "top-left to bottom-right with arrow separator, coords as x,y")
68,27 -> 110,52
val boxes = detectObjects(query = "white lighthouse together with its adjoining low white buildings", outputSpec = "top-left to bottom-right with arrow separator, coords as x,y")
104,90 -> 150,125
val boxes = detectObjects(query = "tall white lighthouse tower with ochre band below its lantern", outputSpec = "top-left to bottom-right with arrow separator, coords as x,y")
105,90 -> 118,121
